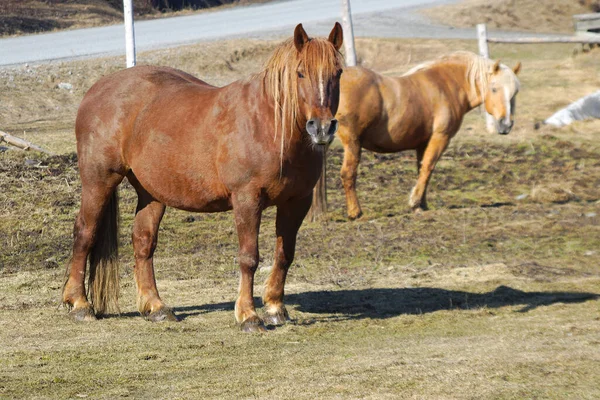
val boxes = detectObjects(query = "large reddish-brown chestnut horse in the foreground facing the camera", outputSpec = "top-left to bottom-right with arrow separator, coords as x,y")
63,23 -> 343,331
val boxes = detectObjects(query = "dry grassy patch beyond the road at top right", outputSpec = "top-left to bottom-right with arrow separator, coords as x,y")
422,0 -> 600,33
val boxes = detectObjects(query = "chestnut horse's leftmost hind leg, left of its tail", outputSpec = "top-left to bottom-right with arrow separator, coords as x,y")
63,175 -> 123,321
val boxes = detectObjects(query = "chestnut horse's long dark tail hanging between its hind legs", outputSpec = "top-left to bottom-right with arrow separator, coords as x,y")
88,189 -> 120,315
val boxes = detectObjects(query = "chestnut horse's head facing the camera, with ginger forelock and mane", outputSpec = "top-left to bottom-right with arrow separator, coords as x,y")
267,22 -> 343,149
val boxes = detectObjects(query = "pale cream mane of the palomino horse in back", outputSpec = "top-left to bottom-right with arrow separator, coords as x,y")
402,51 -> 519,103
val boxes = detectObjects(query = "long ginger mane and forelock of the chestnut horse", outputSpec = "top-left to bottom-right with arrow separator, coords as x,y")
263,38 -> 343,159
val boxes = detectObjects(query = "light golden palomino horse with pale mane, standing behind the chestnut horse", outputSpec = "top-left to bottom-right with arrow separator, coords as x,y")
336,52 -> 521,219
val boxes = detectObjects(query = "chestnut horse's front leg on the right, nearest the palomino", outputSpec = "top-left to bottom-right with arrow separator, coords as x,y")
263,196 -> 312,325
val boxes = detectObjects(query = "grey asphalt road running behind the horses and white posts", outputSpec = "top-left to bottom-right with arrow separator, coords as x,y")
0,0 -> 556,66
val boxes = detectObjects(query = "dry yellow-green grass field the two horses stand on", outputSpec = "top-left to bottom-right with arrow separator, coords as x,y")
0,39 -> 600,399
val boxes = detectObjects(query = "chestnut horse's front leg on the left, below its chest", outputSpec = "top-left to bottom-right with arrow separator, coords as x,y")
232,193 -> 266,332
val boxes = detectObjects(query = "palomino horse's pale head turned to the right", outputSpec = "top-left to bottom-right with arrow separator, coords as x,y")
484,61 -> 521,135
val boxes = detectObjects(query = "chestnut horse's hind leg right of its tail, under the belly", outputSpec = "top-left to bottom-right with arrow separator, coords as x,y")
128,173 -> 172,322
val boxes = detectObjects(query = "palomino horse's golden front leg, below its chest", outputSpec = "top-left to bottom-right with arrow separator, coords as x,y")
408,132 -> 450,211
